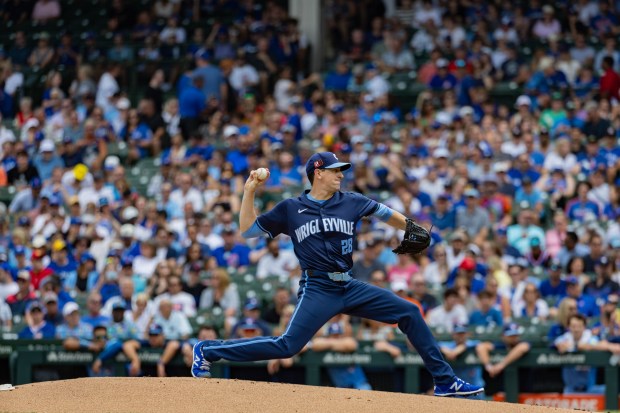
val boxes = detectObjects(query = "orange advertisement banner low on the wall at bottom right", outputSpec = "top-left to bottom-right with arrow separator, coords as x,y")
493,393 -> 605,411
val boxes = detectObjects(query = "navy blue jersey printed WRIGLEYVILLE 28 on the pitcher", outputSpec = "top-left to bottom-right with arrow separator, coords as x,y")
256,190 -> 380,272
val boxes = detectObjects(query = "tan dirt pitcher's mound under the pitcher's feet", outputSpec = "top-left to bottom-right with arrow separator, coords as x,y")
0,377 -> 592,413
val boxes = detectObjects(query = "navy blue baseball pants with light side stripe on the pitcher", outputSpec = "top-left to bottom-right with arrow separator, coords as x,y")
201,271 -> 454,384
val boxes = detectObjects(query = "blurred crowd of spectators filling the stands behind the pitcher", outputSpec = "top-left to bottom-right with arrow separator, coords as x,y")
0,0 -> 620,388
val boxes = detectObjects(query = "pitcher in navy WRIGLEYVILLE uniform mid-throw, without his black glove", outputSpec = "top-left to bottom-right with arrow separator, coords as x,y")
191,152 -> 484,397
